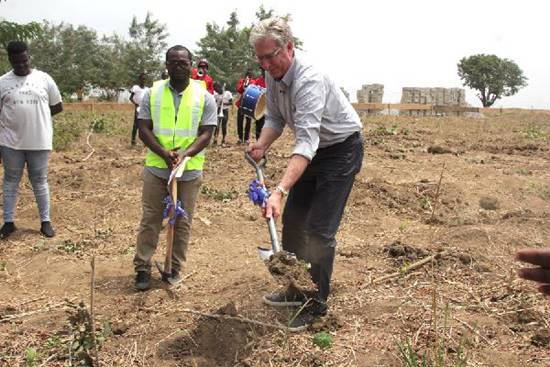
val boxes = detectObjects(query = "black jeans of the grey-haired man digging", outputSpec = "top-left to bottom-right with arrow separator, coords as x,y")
282,132 -> 363,311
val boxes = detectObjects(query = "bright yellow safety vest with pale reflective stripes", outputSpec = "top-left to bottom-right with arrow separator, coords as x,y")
145,79 -> 204,170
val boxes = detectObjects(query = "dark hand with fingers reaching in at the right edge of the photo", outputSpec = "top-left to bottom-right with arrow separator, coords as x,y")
516,248 -> 550,296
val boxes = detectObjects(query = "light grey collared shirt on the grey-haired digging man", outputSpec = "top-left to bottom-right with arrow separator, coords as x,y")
264,56 -> 363,161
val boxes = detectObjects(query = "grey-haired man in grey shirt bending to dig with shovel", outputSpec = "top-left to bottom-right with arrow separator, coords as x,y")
247,18 -> 363,331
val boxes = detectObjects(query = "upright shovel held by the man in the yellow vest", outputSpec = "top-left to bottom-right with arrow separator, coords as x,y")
155,157 -> 191,285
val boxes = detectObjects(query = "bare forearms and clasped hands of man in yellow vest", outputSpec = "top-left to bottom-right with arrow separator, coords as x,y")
138,119 -> 214,171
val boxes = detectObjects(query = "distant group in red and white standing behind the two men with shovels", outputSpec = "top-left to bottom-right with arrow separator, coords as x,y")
130,59 -> 266,146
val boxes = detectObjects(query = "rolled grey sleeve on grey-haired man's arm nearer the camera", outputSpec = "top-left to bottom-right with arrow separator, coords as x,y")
292,78 -> 326,161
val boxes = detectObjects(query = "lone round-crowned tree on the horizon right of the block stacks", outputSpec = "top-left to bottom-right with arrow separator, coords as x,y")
458,54 -> 527,107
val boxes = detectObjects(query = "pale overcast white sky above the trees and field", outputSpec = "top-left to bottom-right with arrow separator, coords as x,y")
0,0 -> 550,109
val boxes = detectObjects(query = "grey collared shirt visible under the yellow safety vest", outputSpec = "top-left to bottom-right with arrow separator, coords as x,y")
138,83 -> 218,181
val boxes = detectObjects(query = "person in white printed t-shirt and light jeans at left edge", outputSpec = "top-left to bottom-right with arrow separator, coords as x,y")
0,41 -> 63,239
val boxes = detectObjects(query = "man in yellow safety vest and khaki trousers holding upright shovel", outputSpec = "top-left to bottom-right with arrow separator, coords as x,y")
134,45 -> 218,291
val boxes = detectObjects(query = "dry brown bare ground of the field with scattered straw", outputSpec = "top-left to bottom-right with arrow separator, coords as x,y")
0,111 -> 550,367
